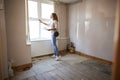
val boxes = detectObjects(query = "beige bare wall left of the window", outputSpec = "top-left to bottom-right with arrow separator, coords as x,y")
5,0 -> 31,66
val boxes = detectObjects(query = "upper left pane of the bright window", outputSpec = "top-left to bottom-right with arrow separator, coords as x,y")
28,1 -> 38,18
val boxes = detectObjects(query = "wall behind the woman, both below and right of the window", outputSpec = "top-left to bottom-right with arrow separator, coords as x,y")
31,3 -> 68,57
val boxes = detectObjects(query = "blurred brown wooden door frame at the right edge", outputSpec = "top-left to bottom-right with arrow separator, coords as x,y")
112,0 -> 120,80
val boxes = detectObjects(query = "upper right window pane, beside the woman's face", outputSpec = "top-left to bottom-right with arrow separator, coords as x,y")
41,3 -> 54,19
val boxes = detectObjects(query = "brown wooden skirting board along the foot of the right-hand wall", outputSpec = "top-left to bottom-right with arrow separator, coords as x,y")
75,51 -> 113,65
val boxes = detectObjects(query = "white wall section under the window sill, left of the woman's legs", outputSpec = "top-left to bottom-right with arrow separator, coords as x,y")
31,40 -> 53,57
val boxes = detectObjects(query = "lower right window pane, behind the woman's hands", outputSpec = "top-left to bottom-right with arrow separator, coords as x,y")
41,24 -> 51,39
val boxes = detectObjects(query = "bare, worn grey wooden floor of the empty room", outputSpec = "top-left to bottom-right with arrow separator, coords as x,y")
11,54 -> 111,80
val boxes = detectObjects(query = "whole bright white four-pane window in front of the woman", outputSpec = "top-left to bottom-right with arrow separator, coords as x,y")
28,0 -> 54,41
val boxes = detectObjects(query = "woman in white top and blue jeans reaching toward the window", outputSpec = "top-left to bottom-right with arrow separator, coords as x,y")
39,13 -> 60,60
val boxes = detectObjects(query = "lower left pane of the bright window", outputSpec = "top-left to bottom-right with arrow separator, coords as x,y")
29,20 -> 39,39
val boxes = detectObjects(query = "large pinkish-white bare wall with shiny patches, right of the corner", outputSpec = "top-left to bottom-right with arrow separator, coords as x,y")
69,0 -> 116,61
